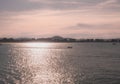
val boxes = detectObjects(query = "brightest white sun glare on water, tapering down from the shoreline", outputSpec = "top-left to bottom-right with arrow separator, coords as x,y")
21,42 -> 52,66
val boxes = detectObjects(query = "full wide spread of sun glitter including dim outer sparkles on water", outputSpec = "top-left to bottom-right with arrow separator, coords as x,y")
0,43 -> 95,84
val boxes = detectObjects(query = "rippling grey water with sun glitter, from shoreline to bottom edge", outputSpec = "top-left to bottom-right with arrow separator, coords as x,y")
0,43 -> 120,84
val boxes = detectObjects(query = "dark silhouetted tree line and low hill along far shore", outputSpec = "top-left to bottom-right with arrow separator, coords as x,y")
0,36 -> 120,42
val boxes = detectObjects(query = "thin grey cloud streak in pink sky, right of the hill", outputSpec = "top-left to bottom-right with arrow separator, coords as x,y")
66,22 -> 120,32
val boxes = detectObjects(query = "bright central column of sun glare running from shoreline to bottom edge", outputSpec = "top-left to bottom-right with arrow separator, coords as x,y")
19,42 -> 57,84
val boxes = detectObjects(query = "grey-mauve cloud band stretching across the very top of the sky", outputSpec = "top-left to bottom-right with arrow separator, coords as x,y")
0,0 -> 120,11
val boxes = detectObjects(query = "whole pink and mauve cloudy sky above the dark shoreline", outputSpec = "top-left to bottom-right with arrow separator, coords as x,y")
0,0 -> 120,38
